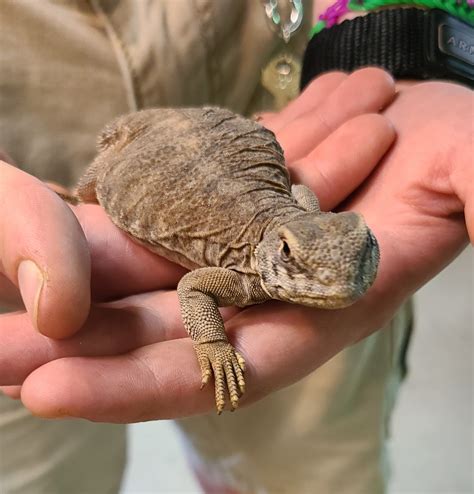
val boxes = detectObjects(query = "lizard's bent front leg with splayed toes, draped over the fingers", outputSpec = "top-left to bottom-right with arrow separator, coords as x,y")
178,267 -> 268,414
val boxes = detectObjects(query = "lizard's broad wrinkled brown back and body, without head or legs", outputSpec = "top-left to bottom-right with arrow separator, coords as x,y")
96,108 -> 302,273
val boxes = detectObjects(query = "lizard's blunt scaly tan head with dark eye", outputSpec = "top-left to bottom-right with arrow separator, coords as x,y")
255,213 -> 379,309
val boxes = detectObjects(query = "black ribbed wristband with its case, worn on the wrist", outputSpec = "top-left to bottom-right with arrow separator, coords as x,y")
301,8 -> 474,88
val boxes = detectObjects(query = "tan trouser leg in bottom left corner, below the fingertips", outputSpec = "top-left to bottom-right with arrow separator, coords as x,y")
0,395 -> 126,494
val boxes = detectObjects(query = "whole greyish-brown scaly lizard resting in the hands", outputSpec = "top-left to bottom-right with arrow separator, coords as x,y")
75,108 -> 379,413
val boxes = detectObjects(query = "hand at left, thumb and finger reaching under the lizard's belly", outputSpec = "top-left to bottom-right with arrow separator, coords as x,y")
0,161 -> 189,339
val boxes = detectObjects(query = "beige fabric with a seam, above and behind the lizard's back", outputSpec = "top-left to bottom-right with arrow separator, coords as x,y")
0,0 -> 310,184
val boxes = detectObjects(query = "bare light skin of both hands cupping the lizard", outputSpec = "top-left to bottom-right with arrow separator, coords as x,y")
0,69 -> 474,422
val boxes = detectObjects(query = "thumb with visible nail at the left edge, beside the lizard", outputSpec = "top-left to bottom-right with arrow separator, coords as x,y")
0,161 -> 90,338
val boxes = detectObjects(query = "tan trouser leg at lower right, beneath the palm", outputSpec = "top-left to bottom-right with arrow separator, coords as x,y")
179,304 -> 412,494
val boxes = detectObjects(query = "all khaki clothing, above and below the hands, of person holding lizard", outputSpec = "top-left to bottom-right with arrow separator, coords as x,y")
0,0 -> 410,494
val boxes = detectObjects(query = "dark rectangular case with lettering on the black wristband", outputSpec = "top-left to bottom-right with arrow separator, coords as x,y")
425,10 -> 474,86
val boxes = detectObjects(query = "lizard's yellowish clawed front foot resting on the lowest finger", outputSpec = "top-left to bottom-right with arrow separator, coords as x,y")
194,341 -> 245,414
